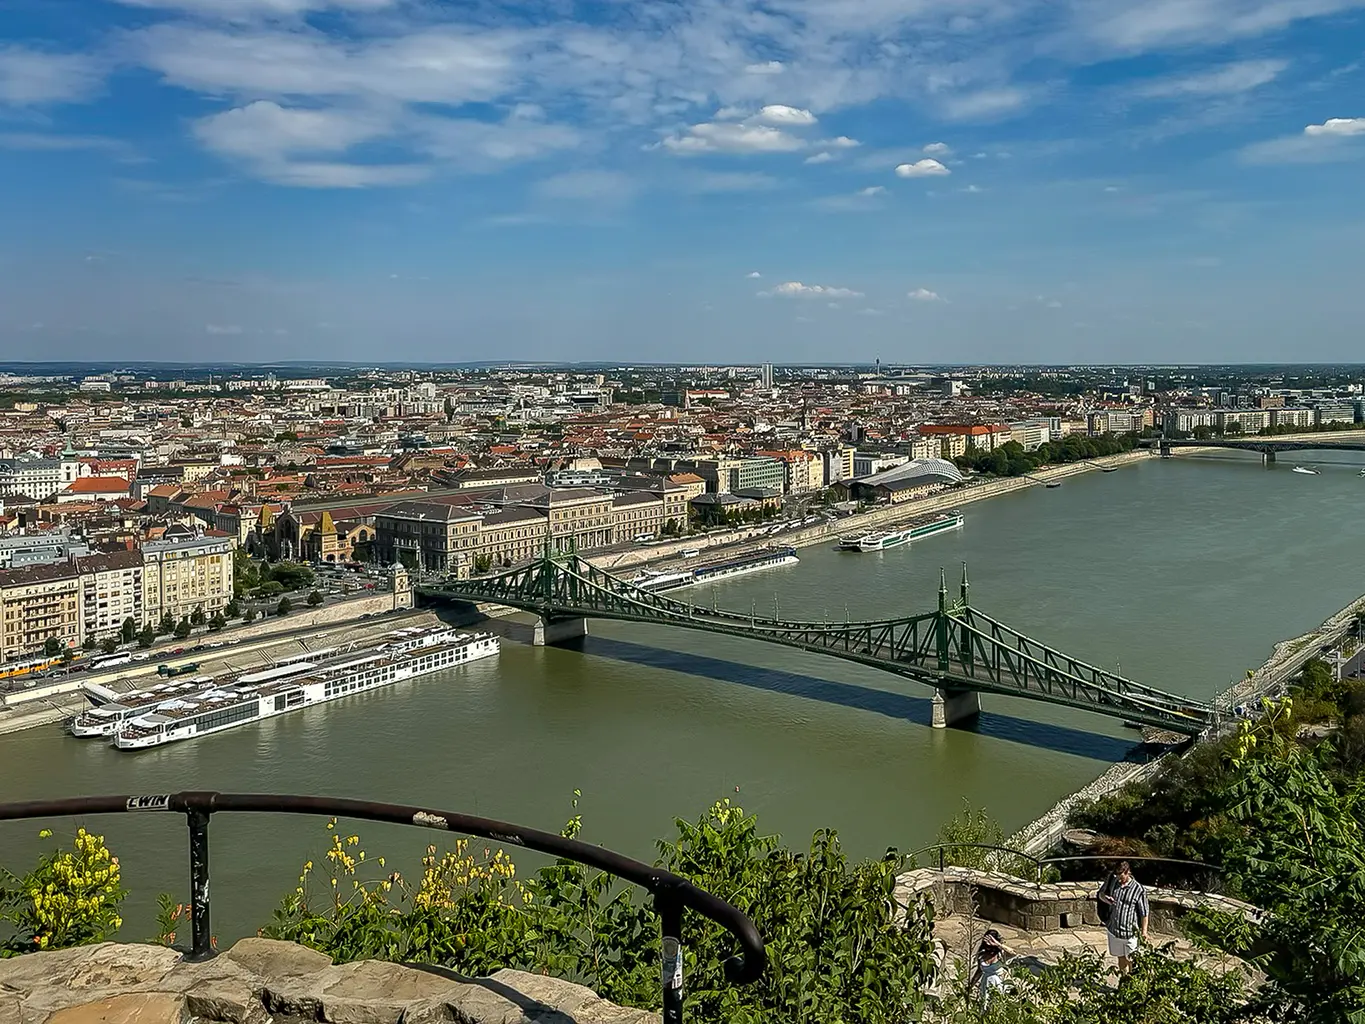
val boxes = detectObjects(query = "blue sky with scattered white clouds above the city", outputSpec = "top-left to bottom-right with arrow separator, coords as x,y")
0,0 -> 1365,363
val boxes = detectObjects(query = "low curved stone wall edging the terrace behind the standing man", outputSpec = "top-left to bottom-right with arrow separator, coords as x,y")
895,867 -> 1260,935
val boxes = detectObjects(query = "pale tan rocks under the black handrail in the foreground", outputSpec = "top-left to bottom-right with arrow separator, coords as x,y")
0,938 -> 659,1024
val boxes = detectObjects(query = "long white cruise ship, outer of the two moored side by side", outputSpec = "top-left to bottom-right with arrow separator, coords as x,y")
113,629 -> 498,750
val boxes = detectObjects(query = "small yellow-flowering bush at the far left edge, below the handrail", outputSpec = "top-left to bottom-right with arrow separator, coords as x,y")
0,829 -> 128,953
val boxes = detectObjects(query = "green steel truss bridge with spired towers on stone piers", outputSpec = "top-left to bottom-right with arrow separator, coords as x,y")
416,550 -> 1216,736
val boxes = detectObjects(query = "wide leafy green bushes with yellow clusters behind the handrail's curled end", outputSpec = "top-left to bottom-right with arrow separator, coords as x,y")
265,801 -> 932,1024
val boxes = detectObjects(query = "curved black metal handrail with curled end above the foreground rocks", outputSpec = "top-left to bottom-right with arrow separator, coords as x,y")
0,791 -> 767,1024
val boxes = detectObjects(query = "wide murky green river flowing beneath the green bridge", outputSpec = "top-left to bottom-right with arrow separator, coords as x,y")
0,453 -> 1365,939
